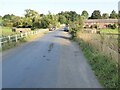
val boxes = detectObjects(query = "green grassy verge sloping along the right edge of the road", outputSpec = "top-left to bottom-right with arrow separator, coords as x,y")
75,32 -> 119,88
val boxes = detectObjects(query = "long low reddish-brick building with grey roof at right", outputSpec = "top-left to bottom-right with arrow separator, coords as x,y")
84,19 -> 118,28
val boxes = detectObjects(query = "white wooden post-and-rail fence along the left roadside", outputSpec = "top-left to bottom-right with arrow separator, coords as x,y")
0,29 -> 48,48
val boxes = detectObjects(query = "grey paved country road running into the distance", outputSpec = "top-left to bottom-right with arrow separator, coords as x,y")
2,30 -> 101,88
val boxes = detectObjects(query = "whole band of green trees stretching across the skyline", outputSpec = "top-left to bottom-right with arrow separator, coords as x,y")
0,9 -> 120,29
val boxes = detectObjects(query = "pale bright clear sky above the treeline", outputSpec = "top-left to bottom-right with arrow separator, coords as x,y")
0,0 -> 119,16
